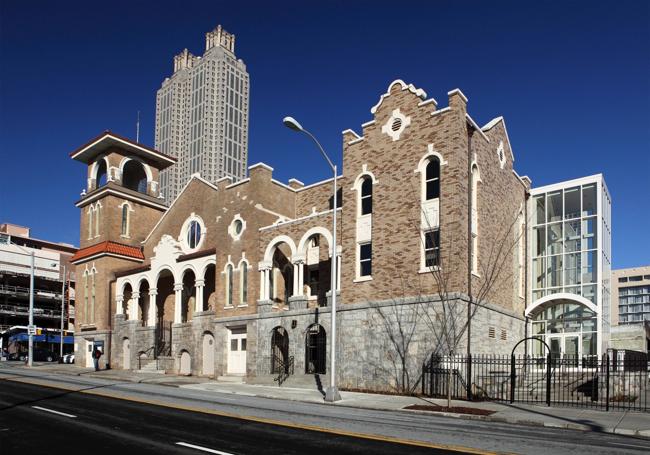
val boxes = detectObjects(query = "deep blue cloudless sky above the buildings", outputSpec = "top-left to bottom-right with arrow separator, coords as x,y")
0,0 -> 650,268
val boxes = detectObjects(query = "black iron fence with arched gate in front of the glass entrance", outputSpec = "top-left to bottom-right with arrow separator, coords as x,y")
421,351 -> 650,412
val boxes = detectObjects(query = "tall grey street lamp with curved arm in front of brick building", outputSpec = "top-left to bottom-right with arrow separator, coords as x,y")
282,117 -> 341,402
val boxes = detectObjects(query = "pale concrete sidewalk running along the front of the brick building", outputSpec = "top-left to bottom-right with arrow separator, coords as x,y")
6,364 -> 650,438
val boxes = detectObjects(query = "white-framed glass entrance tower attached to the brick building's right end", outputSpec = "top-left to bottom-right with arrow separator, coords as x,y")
526,174 -> 611,366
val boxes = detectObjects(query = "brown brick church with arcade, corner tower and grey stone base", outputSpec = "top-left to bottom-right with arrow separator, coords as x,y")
71,80 -> 530,390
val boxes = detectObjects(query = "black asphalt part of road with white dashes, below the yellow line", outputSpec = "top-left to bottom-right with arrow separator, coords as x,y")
0,381 -> 458,454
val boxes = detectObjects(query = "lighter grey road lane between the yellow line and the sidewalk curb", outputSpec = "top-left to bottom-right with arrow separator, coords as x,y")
3,377 -> 650,455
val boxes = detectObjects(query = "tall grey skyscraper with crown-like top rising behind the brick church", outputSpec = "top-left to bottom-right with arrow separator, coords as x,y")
156,25 -> 249,205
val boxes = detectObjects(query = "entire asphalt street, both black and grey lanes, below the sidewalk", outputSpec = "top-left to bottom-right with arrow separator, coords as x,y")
0,369 -> 650,455
